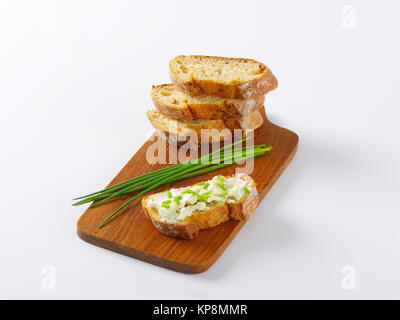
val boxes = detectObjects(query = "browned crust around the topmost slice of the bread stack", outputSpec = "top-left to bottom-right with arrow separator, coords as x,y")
169,55 -> 278,99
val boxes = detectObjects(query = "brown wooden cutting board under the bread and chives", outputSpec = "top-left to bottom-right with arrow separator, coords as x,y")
77,109 -> 298,273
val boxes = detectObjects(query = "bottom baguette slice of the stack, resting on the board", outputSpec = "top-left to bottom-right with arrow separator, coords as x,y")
146,109 -> 264,145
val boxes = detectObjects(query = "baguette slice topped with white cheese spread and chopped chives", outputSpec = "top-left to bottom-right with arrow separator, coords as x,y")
142,174 -> 258,239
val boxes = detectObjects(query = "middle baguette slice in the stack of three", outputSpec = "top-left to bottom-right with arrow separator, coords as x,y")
150,83 -> 265,121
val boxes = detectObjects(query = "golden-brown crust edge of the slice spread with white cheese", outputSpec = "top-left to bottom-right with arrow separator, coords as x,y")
142,176 -> 259,239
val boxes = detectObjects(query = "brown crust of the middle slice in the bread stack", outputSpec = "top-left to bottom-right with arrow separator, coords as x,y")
150,84 -> 265,121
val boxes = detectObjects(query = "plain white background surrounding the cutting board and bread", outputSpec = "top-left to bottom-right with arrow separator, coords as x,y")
0,0 -> 400,299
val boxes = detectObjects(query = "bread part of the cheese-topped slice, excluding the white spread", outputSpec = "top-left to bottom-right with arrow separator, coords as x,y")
142,174 -> 258,239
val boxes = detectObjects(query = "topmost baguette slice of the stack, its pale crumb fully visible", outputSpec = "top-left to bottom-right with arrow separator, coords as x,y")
169,56 -> 278,99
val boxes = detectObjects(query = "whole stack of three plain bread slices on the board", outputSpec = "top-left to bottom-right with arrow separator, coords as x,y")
147,56 -> 278,144
